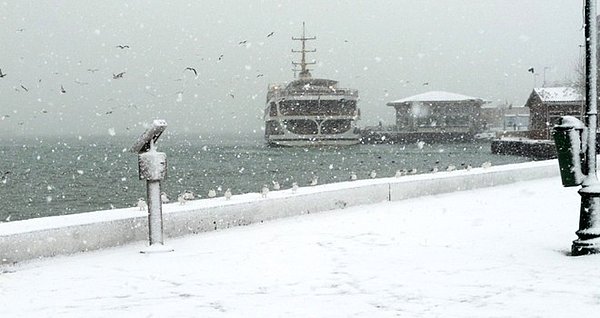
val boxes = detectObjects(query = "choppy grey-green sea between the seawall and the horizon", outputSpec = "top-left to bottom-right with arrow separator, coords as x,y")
0,136 -> 530,222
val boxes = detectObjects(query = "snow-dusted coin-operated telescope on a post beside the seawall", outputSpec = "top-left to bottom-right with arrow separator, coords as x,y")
131,119 -> 170,252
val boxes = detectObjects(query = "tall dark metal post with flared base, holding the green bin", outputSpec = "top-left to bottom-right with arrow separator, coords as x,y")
571,0 -> 600,255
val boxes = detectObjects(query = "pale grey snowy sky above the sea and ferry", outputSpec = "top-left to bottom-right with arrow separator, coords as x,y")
0,0 -> 583,138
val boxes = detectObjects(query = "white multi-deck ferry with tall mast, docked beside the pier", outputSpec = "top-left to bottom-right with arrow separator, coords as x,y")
264,24 -> 360,146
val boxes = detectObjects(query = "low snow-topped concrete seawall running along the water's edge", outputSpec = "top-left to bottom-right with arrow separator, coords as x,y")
0,160 -> 559,264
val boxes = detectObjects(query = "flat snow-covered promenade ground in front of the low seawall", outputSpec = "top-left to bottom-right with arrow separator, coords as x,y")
0,177 -> 600,317
